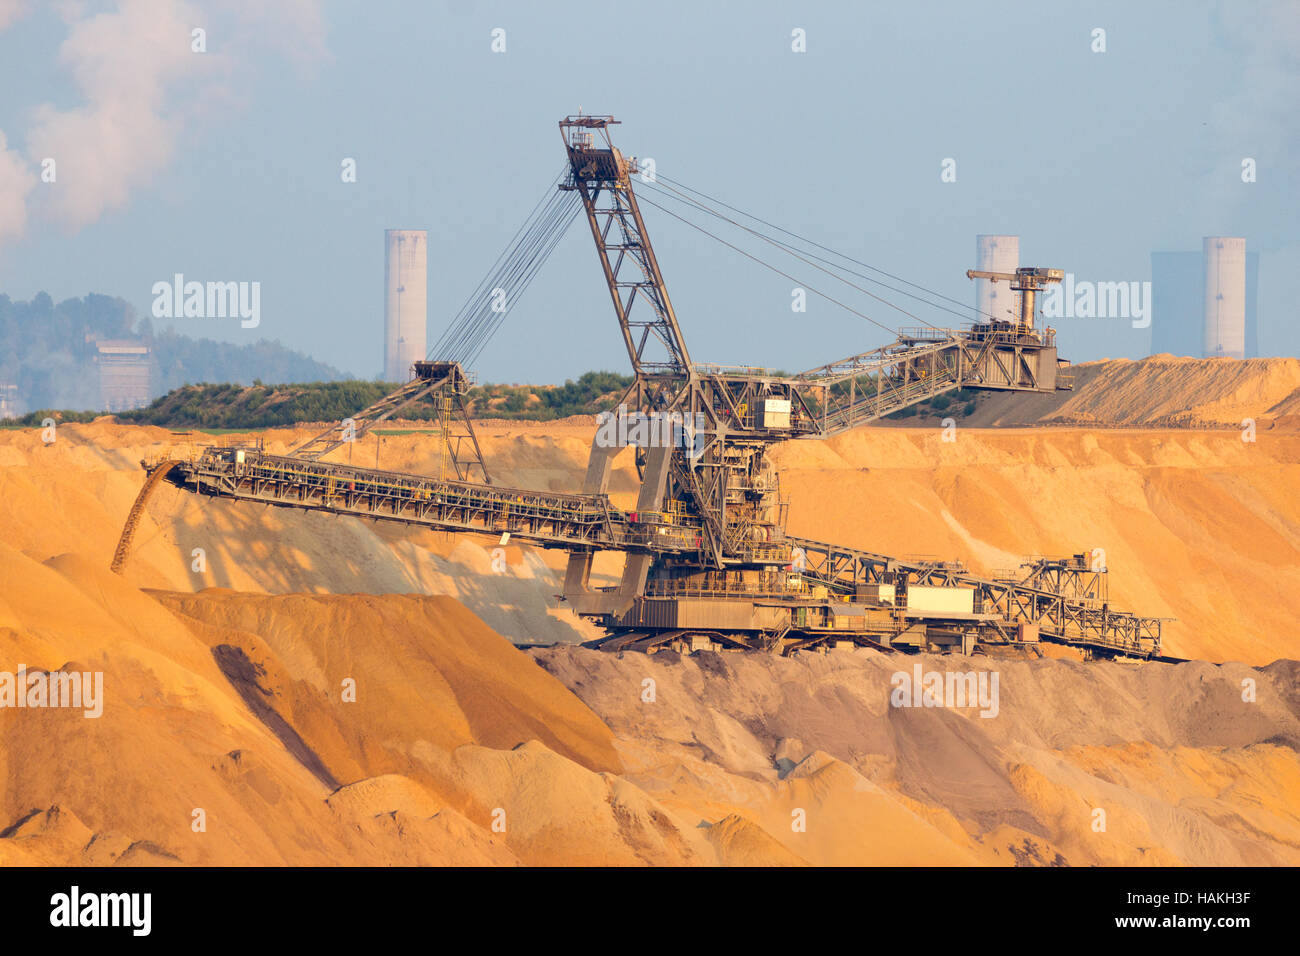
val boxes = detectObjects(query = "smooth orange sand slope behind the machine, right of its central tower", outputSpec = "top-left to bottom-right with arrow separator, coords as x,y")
776,428 -> 1300,663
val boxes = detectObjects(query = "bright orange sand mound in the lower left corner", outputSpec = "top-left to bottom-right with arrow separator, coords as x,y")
0,548 -> 371,864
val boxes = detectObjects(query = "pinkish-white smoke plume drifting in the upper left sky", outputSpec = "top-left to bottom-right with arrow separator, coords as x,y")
0,0 -> 325,243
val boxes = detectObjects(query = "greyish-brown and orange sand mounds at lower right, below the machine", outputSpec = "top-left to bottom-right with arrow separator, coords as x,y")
530,648 -> 1300,865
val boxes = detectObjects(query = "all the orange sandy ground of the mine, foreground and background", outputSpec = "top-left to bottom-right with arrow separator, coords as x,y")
0,359 -> 1300,865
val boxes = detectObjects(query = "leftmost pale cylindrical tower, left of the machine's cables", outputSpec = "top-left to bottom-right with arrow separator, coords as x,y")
384,229 -> 429,382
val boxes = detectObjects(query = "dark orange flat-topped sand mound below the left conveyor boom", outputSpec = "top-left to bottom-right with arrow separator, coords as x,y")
151,592 -> 619,780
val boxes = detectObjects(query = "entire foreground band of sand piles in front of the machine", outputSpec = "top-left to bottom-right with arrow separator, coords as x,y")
0,548 -> 1300,865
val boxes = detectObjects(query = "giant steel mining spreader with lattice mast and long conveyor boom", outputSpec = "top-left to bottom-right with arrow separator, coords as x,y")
113,114 -> 1165,659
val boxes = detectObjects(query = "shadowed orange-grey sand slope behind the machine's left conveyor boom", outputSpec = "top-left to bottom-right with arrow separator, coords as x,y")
0,424 -> 632,643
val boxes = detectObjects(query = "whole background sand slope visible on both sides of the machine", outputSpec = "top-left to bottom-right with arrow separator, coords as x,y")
0,400 -> 1300,663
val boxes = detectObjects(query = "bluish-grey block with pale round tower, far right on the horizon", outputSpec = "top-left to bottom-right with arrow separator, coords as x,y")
1151,237 -> 1260,359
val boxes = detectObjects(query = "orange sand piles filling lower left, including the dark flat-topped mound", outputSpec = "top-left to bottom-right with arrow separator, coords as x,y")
0,548 -> 715,865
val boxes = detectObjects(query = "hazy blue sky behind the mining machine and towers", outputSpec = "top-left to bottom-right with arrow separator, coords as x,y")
0,0 -> 1300,382
